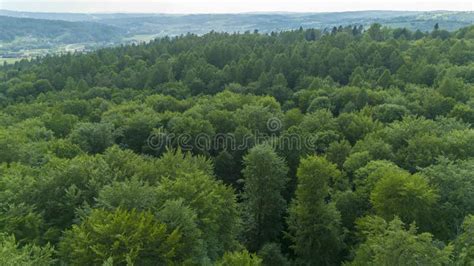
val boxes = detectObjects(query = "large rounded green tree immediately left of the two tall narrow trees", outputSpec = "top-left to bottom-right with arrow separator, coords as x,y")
157,172 -> 241,260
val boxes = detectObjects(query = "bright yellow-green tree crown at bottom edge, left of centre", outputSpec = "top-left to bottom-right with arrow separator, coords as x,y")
59,209 -> 181,265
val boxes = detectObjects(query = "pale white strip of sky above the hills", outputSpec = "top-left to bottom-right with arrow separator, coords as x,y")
0,0 -> 474,13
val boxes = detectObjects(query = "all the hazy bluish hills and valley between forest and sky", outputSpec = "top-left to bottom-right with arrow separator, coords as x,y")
0,10 -> 474,60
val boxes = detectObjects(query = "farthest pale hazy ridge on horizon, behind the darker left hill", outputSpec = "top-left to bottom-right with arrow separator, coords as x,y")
0,10 -> 474,36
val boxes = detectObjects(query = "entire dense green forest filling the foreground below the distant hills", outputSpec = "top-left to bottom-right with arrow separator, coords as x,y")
0,24 -> 474,266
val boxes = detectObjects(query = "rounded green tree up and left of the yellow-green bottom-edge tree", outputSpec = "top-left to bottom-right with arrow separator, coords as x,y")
32,155 -> 114,236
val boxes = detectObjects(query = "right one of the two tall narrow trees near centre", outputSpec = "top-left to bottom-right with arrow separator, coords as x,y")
288,156 -> 343,265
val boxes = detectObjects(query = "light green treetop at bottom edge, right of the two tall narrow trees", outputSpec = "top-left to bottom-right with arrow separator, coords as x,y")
347,216 -> 452,265
